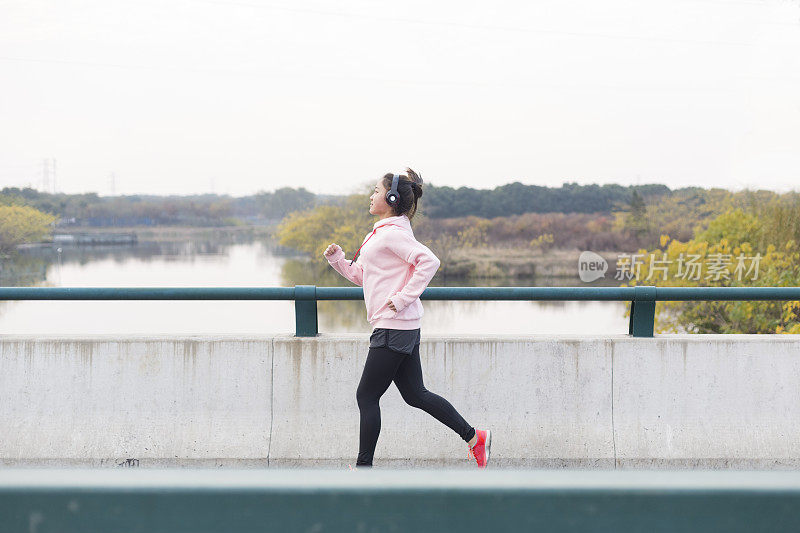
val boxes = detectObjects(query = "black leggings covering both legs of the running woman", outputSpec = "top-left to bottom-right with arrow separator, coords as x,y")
356,344 -> 475,466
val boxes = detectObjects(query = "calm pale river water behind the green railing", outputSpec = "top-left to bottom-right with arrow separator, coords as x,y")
0,236 -> 627,335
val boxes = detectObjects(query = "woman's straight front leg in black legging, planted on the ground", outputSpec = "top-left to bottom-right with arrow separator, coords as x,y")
356,347 -> 408,466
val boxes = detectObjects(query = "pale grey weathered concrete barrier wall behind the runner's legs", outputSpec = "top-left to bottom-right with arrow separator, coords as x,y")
0,334 -> 800,469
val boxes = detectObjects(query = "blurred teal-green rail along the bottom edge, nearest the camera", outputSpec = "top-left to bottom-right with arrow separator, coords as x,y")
0,468 -> 800,533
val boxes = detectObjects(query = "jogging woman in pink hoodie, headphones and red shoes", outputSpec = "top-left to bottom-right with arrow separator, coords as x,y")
324,168 -> 492,468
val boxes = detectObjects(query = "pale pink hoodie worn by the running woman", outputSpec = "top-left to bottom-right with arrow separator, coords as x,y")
328,215 -> 439,329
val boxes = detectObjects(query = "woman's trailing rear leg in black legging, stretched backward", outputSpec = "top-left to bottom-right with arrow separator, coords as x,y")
394,344 -> 475,443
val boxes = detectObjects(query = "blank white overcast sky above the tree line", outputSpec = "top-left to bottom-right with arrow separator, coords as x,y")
0,0 -> 800,196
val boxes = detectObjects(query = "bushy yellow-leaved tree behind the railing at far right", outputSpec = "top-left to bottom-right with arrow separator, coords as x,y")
617,209 -> 800,333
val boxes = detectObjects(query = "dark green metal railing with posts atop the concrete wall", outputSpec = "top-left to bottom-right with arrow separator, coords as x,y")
0,285 -> 800,337
